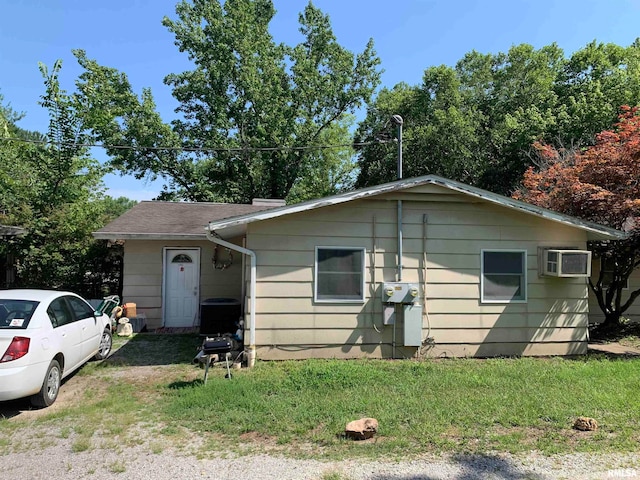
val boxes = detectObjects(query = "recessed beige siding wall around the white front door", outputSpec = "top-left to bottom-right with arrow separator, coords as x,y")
122,239 -> 242,329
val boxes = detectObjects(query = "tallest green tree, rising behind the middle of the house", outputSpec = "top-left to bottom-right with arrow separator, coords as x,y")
76,0 -> 380,202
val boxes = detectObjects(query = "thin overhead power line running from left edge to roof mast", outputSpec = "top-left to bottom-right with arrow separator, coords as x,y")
0,137 -> 387,153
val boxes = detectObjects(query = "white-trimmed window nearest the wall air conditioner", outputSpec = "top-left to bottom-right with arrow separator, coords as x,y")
480,250 -> 527,303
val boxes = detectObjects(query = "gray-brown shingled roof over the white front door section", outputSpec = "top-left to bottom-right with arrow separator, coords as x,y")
93,201 -> 274,240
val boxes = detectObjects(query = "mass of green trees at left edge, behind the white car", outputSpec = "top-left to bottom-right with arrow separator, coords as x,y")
0,61 -> 131,297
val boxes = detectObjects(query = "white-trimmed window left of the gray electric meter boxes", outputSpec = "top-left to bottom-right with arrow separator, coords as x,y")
314,247 -> 365,302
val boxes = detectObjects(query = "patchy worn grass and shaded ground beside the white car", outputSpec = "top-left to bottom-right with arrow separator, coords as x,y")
0,334 -> 201,451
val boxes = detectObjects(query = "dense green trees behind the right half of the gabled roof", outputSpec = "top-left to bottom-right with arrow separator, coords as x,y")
356,40 -> 640,194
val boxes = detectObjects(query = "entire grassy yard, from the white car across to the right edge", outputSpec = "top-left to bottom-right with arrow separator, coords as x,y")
0,334 -> 640,457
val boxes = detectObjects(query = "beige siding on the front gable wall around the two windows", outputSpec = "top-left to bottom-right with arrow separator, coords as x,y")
247,191 -> 588,359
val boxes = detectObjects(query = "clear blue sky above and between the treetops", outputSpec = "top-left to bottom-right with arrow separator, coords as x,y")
0,0 -> 640,200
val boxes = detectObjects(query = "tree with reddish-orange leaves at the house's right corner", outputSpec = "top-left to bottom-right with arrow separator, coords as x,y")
513,106 -> 640,328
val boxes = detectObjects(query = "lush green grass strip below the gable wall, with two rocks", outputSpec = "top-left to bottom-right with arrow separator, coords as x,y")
164,356 -> 640,456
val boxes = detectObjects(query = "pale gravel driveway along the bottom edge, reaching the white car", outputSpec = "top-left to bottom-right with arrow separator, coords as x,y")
0,338 -> 640,480
